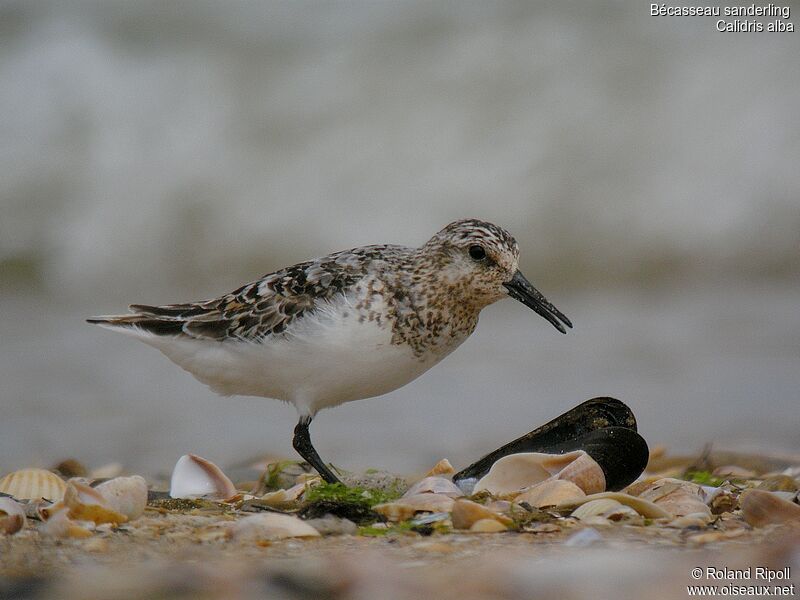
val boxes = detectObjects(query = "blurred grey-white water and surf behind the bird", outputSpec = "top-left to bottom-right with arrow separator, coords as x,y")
0,0 -> 800,473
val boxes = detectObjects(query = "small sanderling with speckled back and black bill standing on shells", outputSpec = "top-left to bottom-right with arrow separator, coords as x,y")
88,219 -> 572,482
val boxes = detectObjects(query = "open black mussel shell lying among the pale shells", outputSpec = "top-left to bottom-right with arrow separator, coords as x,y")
453,398 -> 649,490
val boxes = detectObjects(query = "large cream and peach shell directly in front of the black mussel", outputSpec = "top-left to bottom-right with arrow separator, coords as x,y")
475,450 -> 605,495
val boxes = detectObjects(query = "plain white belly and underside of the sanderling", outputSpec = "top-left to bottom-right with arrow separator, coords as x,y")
138,298 -> 464,415
